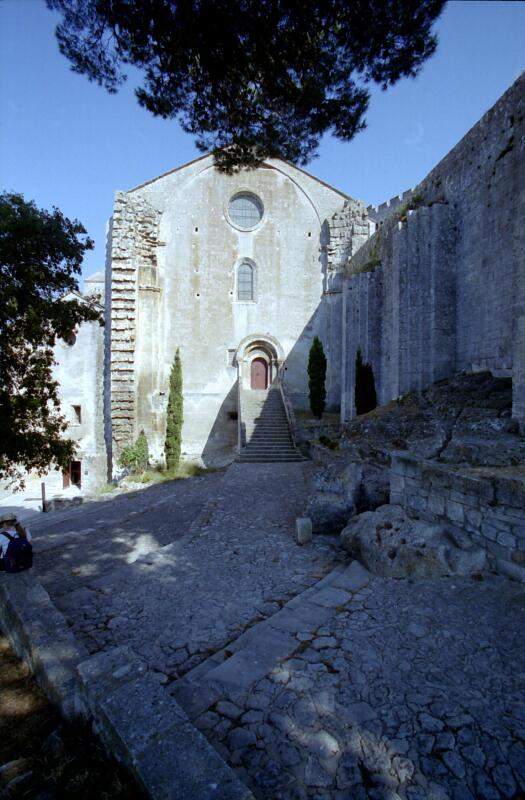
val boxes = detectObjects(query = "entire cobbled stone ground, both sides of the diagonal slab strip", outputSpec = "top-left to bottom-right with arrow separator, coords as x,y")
30,464 -> 525,800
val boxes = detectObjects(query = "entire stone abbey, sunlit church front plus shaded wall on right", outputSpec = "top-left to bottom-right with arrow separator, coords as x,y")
31,75 -> 525,491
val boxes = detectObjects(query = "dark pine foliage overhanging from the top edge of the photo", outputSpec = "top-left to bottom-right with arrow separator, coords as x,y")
46,0 -> 444,171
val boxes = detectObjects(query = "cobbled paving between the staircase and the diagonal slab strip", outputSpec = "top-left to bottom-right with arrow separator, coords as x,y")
35,464 -> 344,681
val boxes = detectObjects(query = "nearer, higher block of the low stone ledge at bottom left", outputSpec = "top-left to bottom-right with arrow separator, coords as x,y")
78,647 -> 253,800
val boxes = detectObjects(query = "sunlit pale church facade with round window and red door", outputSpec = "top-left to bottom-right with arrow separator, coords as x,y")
106,156 -> 366,472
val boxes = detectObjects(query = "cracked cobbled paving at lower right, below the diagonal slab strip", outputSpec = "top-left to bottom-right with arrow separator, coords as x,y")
183,577 -> 525,800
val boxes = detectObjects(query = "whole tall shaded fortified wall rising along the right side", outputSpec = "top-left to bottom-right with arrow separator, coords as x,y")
340,74 -> 525,427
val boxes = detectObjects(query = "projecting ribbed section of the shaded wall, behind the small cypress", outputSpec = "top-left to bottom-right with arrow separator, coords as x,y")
341,203 -> 456,421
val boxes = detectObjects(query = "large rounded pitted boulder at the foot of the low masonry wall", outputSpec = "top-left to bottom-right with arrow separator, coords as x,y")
341,505 -> 485,578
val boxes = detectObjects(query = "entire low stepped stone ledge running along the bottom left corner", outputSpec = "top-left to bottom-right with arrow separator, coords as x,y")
0,572 -> 253,800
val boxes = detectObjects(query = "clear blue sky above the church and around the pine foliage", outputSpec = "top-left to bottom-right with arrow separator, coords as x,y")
0,0 -> 525,282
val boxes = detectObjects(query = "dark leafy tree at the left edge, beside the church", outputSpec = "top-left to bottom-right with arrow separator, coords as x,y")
0,192 -> 100,484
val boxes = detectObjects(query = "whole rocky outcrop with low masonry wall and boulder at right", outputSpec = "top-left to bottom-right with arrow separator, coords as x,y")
307,372 -> 525,580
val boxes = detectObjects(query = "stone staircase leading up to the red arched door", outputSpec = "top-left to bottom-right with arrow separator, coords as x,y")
237,387 -> 305,463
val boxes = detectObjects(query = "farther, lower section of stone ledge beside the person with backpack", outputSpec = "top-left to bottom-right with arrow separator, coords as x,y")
0,572 -> 88,719
